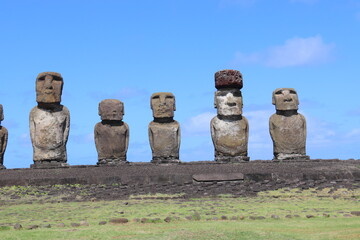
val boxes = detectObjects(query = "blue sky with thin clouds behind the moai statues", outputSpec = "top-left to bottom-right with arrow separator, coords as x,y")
0,0 -> 360,168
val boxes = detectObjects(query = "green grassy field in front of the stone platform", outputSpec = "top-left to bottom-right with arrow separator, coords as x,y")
0,187 -> 360,240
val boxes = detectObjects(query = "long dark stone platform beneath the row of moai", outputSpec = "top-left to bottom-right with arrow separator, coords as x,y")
0,159 -> 360,199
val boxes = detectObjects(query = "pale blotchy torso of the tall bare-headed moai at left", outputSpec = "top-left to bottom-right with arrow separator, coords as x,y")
30,106 -> 70,161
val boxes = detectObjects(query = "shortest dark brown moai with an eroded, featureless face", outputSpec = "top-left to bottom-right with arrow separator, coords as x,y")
94,99 -> 129,165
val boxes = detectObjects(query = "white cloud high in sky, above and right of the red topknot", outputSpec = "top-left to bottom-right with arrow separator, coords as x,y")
234,35 -> 334,67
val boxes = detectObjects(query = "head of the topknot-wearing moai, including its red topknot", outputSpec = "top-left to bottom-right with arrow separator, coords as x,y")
214,70 -> 243,116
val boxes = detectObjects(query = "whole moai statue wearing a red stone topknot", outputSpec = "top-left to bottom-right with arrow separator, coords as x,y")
210,70 -> 250,162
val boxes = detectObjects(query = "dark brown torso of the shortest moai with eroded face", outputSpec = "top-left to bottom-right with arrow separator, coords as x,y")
94,122 -> 129,160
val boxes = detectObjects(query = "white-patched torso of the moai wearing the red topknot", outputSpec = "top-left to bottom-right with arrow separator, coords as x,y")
211,116 -> 249,157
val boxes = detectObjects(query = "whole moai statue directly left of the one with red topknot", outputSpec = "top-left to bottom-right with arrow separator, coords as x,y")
149,92 -> 180,163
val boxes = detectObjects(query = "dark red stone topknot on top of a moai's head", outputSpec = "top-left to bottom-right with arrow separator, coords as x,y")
215,69 -> 243,89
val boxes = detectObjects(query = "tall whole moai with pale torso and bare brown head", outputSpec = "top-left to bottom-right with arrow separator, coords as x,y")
30,72 -> 70,168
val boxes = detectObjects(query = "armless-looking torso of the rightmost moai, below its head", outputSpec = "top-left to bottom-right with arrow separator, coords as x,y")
269,113 -> 306,156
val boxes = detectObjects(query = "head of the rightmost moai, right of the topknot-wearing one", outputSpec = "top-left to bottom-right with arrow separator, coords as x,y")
272,88 -> 299,110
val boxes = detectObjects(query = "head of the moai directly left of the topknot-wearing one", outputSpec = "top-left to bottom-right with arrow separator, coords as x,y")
150,92 -> 176,118
